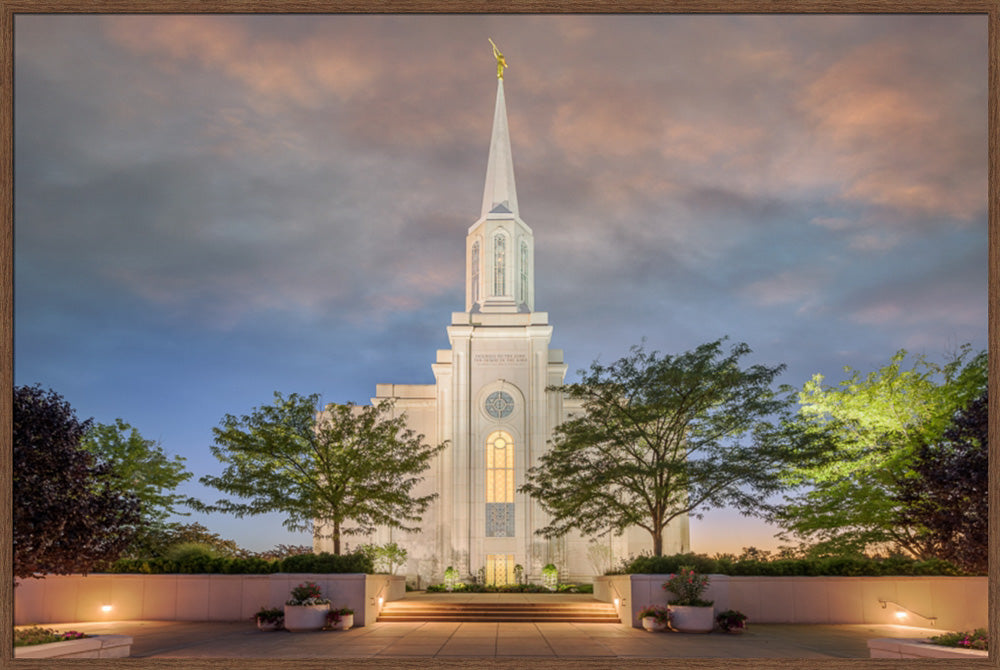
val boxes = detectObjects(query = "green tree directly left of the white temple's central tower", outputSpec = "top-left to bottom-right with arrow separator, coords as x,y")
201,393 -> 444,554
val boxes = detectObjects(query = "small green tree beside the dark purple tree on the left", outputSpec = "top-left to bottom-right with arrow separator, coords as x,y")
81,419 -> 192,527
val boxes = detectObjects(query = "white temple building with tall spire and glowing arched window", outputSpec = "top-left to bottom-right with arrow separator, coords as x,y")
314,64 -> 690,587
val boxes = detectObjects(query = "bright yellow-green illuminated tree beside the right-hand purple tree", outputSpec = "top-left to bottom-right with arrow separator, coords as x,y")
772,345 -> 986,558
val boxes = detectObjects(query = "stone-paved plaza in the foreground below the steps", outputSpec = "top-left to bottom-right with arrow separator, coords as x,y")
27,621 -> 934,659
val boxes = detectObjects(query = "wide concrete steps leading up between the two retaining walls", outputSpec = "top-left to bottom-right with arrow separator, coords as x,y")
378,599 -> 621,623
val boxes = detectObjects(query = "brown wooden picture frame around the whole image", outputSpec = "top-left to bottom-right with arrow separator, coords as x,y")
0,5 -> 1000,670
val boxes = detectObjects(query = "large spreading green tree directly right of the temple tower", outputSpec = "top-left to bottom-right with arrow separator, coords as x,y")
519,338 -> 816,556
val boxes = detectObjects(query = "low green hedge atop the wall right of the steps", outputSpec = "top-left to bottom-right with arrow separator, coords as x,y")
606,554 -> 967,577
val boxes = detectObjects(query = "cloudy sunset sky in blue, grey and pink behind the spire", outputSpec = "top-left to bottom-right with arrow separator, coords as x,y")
14,15 -> 987,553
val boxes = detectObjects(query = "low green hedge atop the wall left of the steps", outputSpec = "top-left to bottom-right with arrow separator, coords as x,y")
108,552 -> 374,575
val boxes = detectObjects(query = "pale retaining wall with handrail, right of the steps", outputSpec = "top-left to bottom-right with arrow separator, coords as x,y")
594,575 -> 987,631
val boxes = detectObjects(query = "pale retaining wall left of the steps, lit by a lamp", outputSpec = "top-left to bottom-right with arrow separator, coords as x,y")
14,573 -> 406,626
